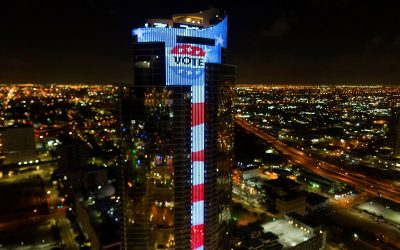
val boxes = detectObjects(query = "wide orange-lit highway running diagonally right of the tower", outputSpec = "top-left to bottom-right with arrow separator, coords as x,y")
235,118 -> 400,203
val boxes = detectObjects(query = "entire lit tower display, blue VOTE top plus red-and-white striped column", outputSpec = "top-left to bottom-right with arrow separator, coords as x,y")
132,18 -> 227,250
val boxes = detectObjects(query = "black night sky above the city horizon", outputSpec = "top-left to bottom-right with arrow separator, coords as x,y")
0,0 -> 400,84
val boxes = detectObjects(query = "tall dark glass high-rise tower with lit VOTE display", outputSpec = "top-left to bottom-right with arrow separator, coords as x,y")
120,9 -> 235,250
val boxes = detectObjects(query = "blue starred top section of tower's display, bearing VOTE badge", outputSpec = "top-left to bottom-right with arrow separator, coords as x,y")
132,18 -> 228,85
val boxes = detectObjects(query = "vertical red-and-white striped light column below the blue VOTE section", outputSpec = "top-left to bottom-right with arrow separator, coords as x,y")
191,84 -> 205,250
